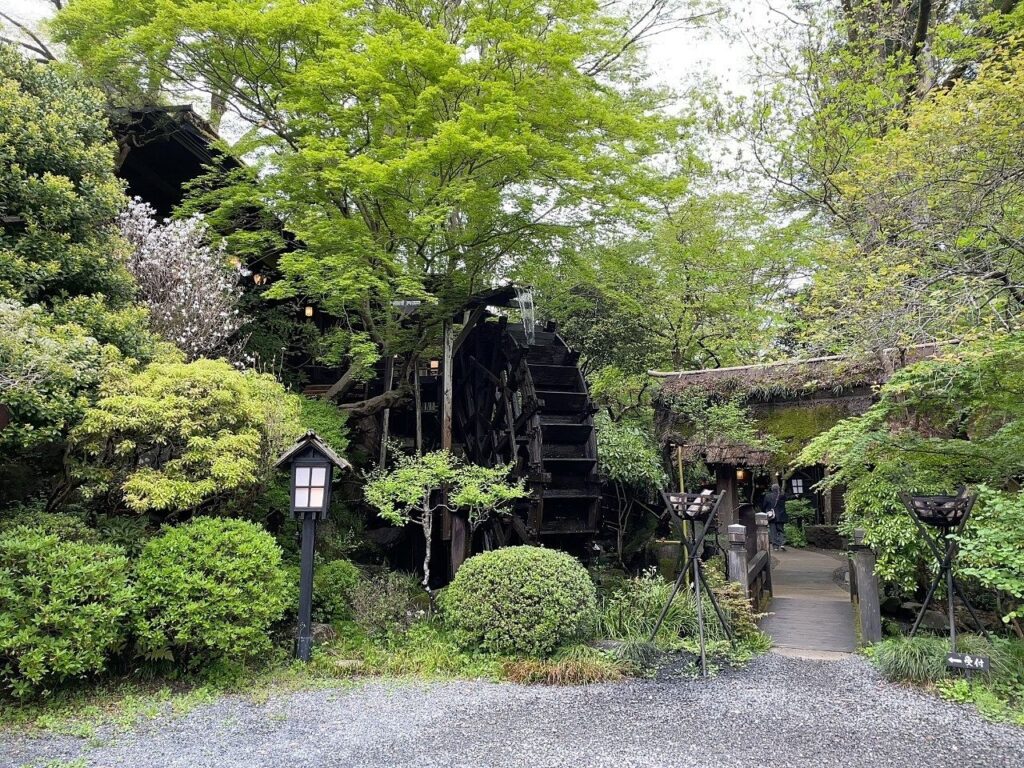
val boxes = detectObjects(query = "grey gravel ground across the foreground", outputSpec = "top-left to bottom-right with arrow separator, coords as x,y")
0,654 -> 1024,768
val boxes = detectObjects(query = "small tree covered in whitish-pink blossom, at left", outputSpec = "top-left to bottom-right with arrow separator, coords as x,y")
118,198 -> 245,360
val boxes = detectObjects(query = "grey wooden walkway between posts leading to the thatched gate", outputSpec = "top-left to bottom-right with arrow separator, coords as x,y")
761,549 -> 856,658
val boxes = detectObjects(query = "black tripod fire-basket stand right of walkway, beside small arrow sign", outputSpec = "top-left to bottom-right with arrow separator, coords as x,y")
900,488 -> 988,653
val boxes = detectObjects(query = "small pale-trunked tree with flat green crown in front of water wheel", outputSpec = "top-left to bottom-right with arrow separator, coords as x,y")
364,451 -> 528,589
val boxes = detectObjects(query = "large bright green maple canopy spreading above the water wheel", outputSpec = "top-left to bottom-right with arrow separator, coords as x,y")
53,0 -> 687,393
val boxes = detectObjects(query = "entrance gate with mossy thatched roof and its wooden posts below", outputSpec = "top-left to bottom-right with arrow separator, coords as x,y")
650,345 -> 937,526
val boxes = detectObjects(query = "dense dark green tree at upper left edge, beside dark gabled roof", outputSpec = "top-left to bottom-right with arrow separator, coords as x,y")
0,45 -> 132,317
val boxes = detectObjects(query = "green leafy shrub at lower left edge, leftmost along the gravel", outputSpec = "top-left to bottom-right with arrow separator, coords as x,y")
0,527 -> 133,696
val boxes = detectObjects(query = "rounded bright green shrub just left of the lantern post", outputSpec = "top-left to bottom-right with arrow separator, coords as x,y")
135,517 -> 291,662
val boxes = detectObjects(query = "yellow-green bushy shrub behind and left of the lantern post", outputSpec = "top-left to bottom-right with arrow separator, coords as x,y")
72,359 -> 302,513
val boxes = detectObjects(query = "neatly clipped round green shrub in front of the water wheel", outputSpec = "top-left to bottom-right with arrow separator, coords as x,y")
440,547 -> 597,656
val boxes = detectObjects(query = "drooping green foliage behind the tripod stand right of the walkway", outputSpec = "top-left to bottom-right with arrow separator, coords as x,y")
798,334 -> 1024,622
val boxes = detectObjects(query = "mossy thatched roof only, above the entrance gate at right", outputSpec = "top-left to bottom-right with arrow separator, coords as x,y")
649,344 -> 941,467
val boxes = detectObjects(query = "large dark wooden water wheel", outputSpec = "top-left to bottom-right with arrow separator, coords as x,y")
453,317 -> 600,551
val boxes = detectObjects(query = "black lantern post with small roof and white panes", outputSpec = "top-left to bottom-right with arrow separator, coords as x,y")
274,432 -> 352,662
